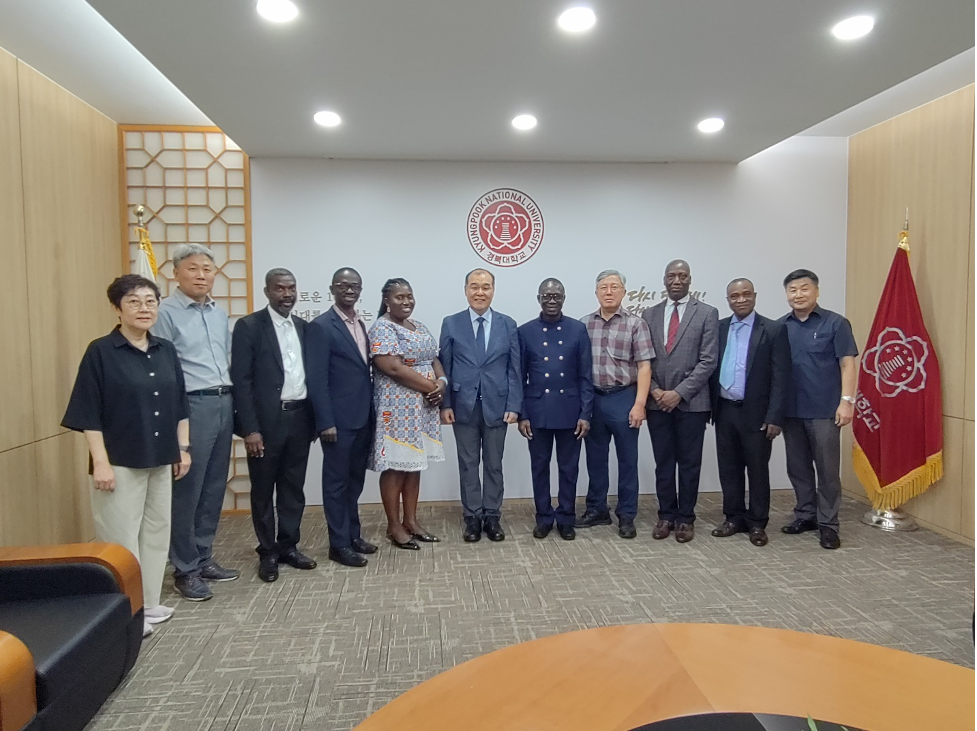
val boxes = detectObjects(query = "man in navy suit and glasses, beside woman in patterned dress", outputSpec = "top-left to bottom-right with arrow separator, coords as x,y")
305,269 -> 377,567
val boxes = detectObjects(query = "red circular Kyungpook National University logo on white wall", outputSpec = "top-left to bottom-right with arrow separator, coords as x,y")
468,188 -> 543,267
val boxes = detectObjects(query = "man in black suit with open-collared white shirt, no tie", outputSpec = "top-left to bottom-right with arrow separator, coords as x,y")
231,269 -> 316,581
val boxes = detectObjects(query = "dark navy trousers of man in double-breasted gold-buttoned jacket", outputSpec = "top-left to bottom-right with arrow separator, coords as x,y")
529,428 -> 580,526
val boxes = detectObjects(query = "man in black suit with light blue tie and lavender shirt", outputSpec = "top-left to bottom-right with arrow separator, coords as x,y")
709,279 -> 790,546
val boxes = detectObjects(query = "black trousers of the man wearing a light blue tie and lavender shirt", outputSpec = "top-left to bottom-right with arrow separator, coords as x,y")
713,400 -> 773,528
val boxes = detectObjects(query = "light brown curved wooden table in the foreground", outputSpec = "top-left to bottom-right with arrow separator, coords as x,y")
356,624 -> 974,731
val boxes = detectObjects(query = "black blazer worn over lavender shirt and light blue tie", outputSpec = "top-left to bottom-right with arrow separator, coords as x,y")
709,312 -> 791,430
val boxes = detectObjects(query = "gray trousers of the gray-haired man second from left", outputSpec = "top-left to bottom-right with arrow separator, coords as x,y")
170,394 -> 234,576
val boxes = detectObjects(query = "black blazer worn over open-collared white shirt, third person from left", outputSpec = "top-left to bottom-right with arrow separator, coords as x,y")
230,308 -> 315,442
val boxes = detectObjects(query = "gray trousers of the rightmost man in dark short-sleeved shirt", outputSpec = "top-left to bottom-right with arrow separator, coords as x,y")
784,419 -> 841,530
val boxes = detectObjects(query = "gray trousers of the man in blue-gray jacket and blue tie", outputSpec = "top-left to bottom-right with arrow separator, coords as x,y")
454,401 -> 509,518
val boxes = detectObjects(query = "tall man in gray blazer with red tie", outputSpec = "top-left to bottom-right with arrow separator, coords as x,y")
641,259 -> 719,543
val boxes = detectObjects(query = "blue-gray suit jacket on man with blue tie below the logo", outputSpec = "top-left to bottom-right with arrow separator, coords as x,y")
438,308 -> 522,426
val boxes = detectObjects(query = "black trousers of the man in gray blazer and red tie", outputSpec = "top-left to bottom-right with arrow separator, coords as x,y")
648,409 -> 709,524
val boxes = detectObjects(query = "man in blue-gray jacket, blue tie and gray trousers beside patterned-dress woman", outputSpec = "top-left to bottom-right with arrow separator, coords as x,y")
439,269 -> 522,543
